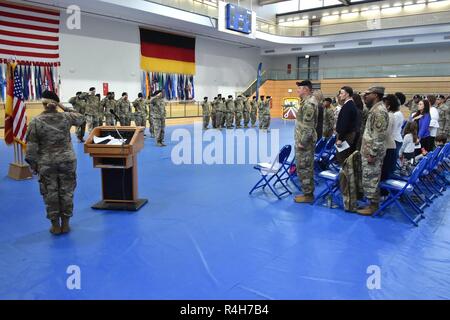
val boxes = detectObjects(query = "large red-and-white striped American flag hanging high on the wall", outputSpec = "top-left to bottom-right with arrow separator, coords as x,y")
0,1 -> 59,63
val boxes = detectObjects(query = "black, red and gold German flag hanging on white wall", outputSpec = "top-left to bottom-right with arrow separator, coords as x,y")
139,29 -> 195,75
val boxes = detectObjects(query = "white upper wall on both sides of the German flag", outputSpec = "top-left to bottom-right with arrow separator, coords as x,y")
60,13 -> 269,101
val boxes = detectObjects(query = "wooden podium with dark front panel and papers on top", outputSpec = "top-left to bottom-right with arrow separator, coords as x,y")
84,126 -> 147,211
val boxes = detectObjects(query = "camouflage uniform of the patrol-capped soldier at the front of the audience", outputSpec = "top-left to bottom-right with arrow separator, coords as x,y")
361,101 -> 389,204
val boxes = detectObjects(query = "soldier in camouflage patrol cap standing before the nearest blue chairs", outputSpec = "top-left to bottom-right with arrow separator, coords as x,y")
357,87 -> 389,215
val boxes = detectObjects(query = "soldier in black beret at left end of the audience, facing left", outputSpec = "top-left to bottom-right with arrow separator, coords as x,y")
294,80 -> 319,203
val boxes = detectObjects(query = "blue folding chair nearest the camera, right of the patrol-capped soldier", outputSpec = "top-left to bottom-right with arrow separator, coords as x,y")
373,160 -> 428,226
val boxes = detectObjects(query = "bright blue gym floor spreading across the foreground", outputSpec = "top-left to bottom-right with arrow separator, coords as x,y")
0,119 -> 450,300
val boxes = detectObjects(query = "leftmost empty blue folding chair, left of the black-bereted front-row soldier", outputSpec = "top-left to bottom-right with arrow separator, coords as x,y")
249,145 -> 292,199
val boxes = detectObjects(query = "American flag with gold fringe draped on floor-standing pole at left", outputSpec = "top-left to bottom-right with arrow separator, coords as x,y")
5,63 -> 27,146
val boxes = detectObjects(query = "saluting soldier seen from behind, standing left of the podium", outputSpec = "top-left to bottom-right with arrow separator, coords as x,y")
25,91 -> 84,235
